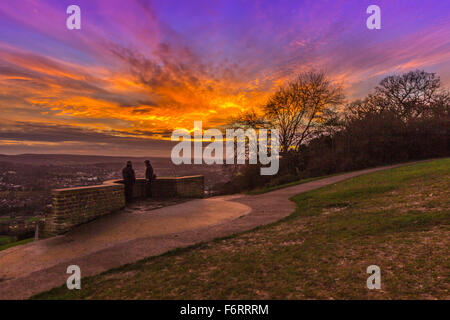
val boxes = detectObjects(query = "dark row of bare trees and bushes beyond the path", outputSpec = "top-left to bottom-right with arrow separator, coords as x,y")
225,70 -> 450,192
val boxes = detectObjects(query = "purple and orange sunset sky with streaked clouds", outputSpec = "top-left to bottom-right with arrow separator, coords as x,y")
0,0 -> 450,156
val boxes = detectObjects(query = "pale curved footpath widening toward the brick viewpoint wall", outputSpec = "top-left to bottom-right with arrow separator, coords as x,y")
0,163 -> 411,299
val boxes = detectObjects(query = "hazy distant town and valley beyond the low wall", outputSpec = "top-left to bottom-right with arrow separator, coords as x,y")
0,154 -> 232,240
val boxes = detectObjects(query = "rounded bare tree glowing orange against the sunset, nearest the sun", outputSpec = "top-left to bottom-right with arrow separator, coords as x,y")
263,72 -> 344,152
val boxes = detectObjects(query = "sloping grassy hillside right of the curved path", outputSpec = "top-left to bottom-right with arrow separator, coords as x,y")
34,159 -> 450,299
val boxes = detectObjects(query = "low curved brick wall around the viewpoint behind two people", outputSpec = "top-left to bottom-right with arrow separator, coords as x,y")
40,176 -> 204,237
